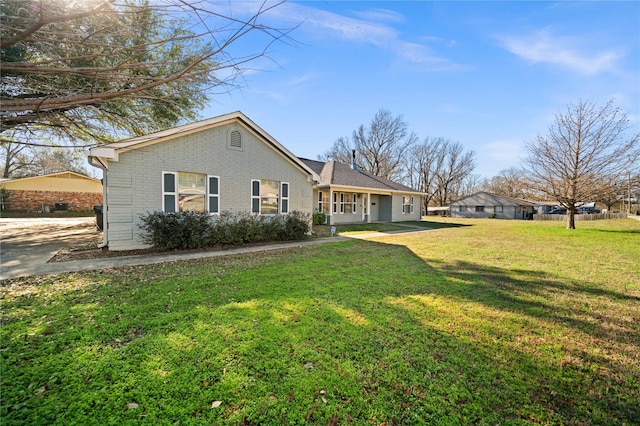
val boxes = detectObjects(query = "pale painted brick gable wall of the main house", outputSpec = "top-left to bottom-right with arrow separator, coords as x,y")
106,124 -> 313,250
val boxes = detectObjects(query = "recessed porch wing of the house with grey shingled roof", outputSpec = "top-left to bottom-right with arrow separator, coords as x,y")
302,154 -> 422,225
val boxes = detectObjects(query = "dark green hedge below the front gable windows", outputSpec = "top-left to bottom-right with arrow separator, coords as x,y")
140,211 -> 310,250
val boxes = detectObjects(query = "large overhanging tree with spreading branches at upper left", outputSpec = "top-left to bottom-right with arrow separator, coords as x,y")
0,0 -> 289,172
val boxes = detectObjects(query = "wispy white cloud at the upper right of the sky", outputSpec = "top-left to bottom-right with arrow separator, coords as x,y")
499,28 -> 622,75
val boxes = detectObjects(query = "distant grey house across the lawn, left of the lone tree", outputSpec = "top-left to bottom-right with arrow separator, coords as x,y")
449,192 -> 537,219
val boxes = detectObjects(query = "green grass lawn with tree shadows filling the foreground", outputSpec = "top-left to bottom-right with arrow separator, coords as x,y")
0,219 -> 640,425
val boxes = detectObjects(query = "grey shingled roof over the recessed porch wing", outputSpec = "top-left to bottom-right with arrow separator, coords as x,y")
301,158 -> 421,194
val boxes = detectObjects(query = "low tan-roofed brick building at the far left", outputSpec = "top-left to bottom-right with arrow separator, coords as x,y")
0,172 -> 102,212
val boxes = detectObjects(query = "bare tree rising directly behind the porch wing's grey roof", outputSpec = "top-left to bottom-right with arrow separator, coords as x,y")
319,109 -> 418,180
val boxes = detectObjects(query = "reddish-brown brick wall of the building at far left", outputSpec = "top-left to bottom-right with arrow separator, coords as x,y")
5,191 -> 102,211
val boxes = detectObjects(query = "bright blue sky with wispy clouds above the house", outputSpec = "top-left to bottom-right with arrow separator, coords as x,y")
202,0 -> 640,177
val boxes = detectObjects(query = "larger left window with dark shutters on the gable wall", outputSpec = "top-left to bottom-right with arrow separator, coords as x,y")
162,172 -> 220,213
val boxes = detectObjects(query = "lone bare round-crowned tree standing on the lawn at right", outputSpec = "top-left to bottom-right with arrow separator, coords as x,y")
524,100 -> 640,229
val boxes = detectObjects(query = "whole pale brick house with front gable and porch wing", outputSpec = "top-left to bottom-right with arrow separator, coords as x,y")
88,111 -> 420,250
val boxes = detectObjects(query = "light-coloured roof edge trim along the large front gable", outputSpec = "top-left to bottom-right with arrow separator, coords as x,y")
88,111 -> 318,181
